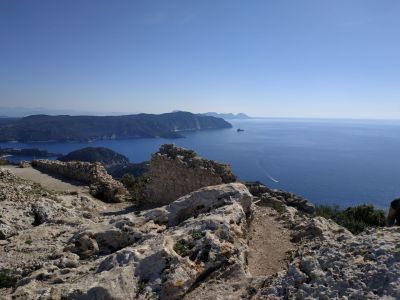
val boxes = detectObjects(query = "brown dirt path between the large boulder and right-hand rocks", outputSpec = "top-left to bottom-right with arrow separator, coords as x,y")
248,206 -> 295,276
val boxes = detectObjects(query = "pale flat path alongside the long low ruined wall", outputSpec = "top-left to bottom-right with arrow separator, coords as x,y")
3,166 -> 89,193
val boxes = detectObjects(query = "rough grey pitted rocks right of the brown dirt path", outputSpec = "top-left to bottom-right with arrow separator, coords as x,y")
259,218 -> 400,299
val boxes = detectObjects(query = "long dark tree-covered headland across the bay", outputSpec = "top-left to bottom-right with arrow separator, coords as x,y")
0,112 -> 232,142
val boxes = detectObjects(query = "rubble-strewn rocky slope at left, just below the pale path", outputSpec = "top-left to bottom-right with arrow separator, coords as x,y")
0,168 -> 104,286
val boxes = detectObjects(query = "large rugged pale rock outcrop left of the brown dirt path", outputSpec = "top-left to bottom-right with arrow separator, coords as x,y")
3,183 -> 252,299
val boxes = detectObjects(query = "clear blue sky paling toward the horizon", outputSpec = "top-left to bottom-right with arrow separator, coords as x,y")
0,0 -> 400,118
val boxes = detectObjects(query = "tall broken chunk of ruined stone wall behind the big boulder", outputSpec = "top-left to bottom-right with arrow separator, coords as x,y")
144,144 -> 236,205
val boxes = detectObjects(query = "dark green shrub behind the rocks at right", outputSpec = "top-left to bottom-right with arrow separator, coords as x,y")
316,204 -> 386,234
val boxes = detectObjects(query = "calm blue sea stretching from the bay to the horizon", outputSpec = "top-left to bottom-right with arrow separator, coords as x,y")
0,119 -> 400,208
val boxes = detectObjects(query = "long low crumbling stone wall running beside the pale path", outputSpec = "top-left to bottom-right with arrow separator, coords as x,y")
32,159 -> 129,202
